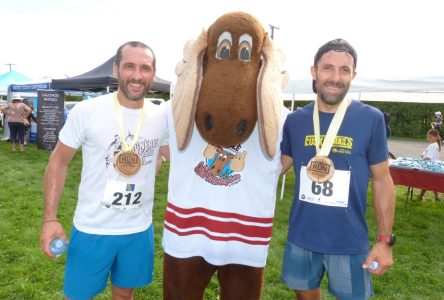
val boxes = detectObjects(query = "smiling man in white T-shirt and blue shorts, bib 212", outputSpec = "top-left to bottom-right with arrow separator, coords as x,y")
40,42 -> 169,299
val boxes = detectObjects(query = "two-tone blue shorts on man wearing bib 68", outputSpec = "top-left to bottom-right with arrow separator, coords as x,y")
281,240 -> 373,300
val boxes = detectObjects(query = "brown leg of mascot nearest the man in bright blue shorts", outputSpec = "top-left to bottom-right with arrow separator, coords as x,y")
163,253 -> 216,300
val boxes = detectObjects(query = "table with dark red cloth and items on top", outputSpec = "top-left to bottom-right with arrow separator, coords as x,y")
390,157 -> 444,207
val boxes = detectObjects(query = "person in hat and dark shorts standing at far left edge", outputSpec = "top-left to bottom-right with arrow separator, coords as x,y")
0,97 -> 32,152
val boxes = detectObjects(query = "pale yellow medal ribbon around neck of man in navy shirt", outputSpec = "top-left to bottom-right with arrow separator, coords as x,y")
313,99 -> 349,157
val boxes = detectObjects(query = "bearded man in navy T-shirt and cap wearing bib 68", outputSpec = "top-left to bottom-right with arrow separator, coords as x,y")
281,39 -> 395,300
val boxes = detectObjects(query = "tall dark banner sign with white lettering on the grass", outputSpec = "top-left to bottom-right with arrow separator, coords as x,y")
37,90 -> 65,150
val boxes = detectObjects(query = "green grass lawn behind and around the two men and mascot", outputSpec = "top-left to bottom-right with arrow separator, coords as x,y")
0,141 -> 444,300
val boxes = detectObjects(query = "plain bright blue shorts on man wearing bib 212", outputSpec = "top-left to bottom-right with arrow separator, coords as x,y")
63,225 -> 154,300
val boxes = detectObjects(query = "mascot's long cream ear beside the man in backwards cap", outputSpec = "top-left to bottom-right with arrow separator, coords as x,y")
257,35 -> 288,158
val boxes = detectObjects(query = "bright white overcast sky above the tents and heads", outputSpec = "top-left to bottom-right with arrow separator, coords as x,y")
0,0 -> 444,81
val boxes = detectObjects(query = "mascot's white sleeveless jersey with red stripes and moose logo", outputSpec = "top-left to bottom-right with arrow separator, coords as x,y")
162,102 -> 287,267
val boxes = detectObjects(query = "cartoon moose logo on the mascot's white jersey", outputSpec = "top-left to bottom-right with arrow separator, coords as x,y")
194,144 -> 247,186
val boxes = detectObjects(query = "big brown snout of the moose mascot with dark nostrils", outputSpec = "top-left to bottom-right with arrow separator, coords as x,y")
196,61 -> 259,147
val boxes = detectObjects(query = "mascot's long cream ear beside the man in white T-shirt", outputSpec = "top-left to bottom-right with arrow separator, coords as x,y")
172,30 -> 207,150
